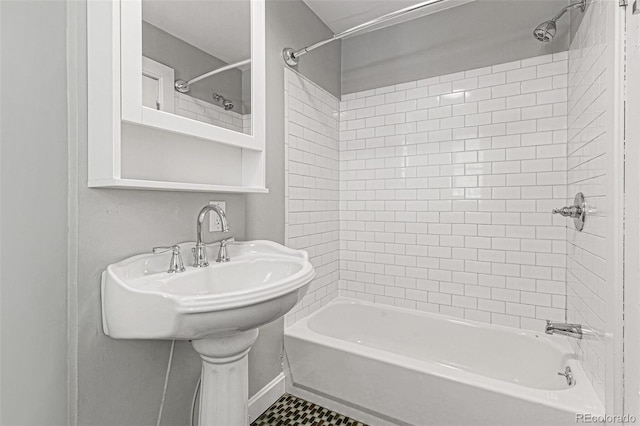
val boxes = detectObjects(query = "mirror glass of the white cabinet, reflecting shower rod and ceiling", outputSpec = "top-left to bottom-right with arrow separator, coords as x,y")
142,0 -> 252,134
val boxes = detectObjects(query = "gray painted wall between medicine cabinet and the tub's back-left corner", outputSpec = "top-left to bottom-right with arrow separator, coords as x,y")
247,0 -> 340,394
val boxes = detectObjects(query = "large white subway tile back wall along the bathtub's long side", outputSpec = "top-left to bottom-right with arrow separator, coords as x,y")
340,52 -> 568,331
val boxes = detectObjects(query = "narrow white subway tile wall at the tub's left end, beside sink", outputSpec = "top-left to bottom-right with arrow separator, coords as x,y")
284,69 -> 340,324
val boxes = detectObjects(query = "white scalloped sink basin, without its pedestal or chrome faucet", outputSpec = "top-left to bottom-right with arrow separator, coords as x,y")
102,241 -> 315,340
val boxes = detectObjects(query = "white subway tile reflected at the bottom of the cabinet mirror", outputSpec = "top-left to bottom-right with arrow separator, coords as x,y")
174,92 -> 251,134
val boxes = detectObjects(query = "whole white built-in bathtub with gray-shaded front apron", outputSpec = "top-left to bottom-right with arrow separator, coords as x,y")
284,298 -> 604,426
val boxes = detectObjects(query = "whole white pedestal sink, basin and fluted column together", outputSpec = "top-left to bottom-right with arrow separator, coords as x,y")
102,241 -> 315,426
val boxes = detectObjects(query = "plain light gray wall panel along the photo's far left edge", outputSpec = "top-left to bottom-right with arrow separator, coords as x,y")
0,1 -> 67,426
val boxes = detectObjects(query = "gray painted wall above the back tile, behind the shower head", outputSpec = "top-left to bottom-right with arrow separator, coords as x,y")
342,0 -> 569,94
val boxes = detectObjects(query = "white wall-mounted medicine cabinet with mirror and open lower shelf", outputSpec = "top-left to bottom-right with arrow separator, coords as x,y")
87,0 -> 267,192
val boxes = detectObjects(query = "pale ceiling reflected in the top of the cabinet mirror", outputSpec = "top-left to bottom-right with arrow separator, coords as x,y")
142,0 -> 251,63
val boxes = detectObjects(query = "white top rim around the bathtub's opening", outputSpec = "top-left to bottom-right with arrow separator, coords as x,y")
284,296 -> 605,415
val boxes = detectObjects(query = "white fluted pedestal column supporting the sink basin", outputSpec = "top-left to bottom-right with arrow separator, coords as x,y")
193,329 -> 258,426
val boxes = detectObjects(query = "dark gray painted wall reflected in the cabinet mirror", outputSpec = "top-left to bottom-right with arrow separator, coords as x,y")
142,21 -> 251,114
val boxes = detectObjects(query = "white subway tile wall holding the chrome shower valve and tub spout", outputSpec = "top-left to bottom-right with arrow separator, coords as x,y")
567,1 -> 614,402
